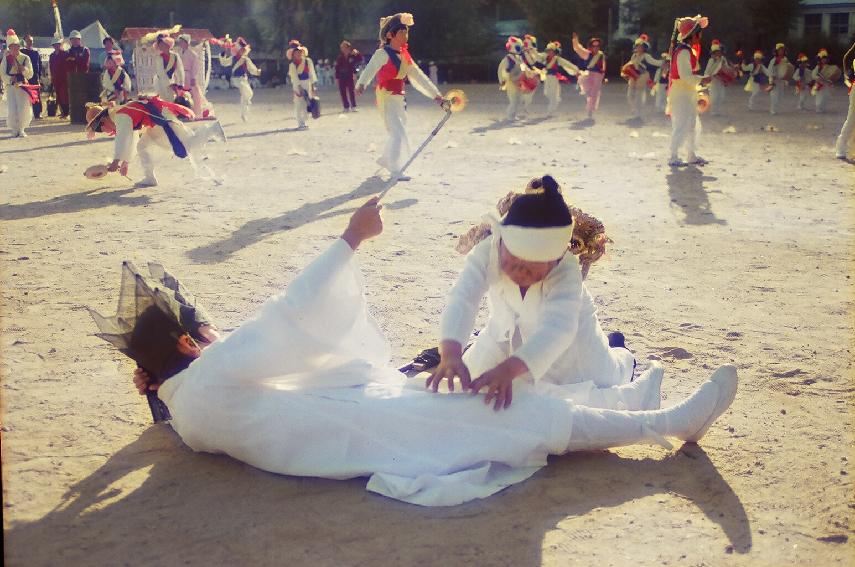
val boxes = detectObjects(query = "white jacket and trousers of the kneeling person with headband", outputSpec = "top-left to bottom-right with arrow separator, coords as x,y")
448,236 -> 640,409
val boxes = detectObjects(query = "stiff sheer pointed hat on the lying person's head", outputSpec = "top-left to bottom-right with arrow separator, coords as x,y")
88,262 -> 210,381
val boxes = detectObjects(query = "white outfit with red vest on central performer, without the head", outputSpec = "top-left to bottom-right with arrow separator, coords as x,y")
356,46 -> 441,175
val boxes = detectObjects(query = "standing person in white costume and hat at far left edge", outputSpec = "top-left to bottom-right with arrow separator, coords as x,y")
0,29 -> 33,138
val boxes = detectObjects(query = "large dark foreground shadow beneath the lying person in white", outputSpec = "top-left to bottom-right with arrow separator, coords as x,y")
5,425 -> 752,567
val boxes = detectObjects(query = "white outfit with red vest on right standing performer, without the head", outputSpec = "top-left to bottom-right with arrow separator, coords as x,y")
668,40 -> 701,164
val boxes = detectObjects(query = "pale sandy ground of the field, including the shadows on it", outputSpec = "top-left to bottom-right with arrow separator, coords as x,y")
0,84 -> 855,566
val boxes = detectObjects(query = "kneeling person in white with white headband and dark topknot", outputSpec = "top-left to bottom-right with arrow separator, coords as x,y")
433,176 -> 660,409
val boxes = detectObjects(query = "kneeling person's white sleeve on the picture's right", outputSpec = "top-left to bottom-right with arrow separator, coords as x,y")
513,262 -> 583,380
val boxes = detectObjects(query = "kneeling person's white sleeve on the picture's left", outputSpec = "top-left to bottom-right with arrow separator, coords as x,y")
439,237 -> 494,346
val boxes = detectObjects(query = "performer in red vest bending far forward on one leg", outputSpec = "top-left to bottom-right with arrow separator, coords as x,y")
86,97 -> 226,187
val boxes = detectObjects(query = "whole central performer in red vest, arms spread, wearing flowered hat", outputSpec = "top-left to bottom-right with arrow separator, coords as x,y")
356,13 -> 443,181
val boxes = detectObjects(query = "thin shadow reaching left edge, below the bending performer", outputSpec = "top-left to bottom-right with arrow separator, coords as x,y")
0,187 -> 151,220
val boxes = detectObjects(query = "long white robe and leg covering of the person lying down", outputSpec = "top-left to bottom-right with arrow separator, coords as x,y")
158,240 -> 736,506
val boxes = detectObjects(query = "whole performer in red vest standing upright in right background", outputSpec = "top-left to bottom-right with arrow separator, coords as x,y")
668,14 -> 710,167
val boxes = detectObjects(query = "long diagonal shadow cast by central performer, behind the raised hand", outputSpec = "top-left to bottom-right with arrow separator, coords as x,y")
187,176 -> 417,264
